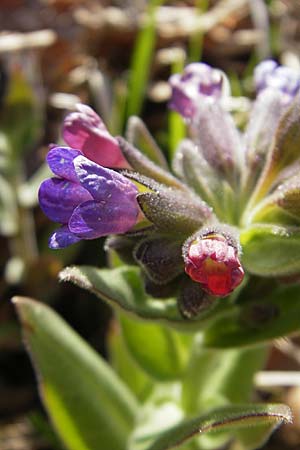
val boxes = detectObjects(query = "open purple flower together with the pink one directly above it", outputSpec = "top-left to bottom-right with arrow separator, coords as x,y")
39,105 -> 139,249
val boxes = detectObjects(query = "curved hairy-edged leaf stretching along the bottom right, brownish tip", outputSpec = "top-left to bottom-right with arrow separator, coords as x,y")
130,404 -> 292,450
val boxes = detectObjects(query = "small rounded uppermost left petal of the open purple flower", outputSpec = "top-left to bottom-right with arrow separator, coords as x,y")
47,147 -> 81,183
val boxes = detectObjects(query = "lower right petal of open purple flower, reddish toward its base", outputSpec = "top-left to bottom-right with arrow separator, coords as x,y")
69,200 -> 138,239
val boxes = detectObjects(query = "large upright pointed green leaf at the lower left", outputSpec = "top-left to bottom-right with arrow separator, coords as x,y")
14,297 -> 138,450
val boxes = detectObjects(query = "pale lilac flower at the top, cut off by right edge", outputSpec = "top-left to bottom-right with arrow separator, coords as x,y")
254,60 -> 300,104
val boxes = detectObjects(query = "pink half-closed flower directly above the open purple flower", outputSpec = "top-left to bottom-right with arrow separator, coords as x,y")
63,103 -> 129,168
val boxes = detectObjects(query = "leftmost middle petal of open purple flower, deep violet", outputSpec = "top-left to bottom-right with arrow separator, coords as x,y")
39,178 -> 91,223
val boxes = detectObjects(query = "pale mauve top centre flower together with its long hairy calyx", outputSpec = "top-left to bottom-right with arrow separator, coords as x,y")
170,63 -> 241,178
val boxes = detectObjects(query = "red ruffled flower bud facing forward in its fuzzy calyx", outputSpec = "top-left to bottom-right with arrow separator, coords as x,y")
183,232 -> 244,297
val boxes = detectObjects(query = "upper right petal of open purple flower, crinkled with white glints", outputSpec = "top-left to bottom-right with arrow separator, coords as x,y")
74,156 -> 138,203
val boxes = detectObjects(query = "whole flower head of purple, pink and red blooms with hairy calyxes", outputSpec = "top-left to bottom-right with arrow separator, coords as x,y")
39,61 -> 300,318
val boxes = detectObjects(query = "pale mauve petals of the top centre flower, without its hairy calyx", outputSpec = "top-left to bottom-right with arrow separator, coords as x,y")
169,63 -> 224,119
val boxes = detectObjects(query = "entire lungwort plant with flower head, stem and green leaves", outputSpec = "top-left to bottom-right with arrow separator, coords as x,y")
15,61 -> 300,450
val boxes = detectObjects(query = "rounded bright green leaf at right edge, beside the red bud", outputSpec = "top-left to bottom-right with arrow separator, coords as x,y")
240,224 -> 300,277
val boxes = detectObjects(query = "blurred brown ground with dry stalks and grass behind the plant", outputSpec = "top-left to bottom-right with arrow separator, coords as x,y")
0,0 -> 300,450
